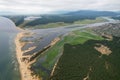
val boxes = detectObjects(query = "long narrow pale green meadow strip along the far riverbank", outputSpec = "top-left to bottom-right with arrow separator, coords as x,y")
28,17 -> 107,29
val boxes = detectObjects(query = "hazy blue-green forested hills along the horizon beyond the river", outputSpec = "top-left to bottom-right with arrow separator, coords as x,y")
6,10 -> 120,28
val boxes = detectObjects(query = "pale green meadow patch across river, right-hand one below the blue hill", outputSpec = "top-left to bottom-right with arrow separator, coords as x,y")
74,17 -> 108,24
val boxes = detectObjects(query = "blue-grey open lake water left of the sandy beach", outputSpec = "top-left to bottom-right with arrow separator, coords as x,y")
0,17 -> 20,80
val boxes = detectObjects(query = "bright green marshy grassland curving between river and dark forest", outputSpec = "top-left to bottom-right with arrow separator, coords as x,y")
31,29 -> 103,79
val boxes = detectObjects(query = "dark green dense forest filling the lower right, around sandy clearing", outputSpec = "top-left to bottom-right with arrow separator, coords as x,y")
49,36 -> 120,80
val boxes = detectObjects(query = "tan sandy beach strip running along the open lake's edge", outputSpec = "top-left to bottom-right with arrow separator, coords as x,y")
15,32 -> 41,80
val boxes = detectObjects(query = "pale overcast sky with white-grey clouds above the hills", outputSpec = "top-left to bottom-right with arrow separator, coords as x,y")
0,0 -> 120,14
